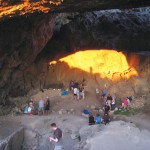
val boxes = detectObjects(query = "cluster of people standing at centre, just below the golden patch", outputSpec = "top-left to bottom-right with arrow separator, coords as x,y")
69,80 -> 85,100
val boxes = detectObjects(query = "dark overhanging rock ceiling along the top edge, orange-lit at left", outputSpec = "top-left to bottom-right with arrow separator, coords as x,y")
0,0 -> 150,20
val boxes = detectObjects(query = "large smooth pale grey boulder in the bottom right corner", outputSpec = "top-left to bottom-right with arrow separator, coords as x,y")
85,121 -> 150,150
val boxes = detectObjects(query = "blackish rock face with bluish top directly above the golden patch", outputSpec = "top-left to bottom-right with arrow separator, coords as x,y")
56,7 -> 150,51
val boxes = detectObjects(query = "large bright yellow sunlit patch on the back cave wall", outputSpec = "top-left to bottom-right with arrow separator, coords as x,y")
50,50 -> 138,80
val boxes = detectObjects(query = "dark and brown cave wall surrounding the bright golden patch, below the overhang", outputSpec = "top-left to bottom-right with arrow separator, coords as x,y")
0,7 -> 150,104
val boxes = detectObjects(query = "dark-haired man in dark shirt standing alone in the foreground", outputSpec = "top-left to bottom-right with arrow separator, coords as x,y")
49,123 -> 63,150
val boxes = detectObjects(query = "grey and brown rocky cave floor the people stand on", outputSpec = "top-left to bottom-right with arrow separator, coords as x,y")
0,89 -> 150,150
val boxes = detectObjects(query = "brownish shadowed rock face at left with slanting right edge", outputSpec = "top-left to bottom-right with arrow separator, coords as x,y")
0,15 -> 55,103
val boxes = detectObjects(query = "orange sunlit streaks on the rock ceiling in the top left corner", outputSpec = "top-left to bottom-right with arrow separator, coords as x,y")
0,0 -> 63,18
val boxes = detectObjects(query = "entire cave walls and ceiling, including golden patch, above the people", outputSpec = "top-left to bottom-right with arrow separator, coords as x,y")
0,0 -> 150,150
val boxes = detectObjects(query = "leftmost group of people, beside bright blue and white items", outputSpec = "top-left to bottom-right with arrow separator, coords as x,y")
23,97 -> 50,115
